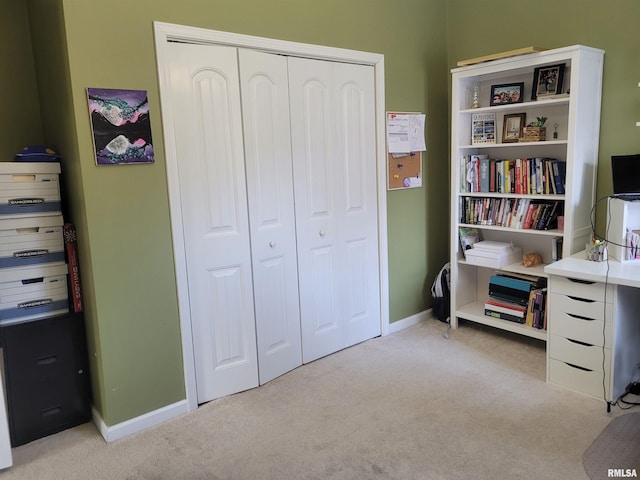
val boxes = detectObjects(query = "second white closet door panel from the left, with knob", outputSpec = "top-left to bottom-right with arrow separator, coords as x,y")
239,49 -> 302,384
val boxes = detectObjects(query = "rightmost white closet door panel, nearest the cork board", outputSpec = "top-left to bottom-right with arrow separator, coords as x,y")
333,63 -> 381,345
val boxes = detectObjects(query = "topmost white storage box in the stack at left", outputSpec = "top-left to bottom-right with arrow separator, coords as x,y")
0,162 -> 62,218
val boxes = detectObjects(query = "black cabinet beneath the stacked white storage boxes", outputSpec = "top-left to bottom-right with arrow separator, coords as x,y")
0,313 -> 91,447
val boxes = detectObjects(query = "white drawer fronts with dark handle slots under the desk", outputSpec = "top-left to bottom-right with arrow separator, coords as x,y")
547,275 -> 614,401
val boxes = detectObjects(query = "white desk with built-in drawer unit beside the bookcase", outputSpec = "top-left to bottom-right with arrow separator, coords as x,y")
544,252 -> 640,403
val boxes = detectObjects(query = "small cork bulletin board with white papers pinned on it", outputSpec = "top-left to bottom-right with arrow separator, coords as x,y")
387,112 -> 426,190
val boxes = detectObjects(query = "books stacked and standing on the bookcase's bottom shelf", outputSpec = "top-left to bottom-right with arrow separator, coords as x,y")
484,273 -> 546,329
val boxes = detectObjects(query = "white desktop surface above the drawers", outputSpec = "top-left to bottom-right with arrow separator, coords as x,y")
544,251 -> 640,288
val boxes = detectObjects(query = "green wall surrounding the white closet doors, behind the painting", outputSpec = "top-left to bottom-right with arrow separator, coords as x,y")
20,0 -> 448,425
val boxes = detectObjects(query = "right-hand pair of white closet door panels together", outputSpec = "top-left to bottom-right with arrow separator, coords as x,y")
289,58 -> 380,363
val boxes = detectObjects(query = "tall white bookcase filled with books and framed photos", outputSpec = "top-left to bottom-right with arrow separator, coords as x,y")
450,45 -> 604,341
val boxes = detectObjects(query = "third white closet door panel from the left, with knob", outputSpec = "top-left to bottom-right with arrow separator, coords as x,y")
289,58 -> 345,363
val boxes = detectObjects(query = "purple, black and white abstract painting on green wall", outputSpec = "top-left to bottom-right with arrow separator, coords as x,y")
87,88 -> 154,165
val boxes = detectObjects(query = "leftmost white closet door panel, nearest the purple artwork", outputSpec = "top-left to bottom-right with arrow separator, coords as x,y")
168,43 -> 258,403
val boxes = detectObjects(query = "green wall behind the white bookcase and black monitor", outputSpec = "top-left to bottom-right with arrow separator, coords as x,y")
447,0 -> 640,235
